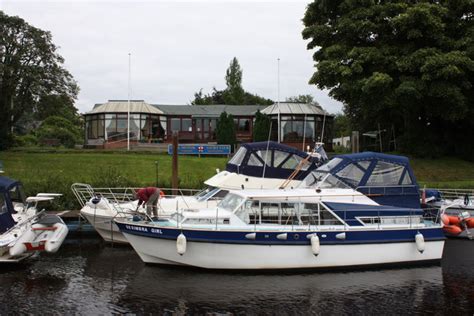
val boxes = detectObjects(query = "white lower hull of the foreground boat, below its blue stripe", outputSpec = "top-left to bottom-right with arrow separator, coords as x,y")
121,233 -> 444,269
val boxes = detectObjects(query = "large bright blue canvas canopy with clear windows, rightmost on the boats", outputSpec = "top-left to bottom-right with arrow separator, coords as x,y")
305,152 -> 420,208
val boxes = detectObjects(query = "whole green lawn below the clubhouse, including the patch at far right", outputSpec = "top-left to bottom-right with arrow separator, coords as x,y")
0,150 -> 474,208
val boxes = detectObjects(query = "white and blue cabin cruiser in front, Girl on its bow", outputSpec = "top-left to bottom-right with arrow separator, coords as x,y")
115,187 -> 445,269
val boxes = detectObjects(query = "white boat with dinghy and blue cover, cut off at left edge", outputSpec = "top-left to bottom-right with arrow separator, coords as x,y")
0,177 -> 68,262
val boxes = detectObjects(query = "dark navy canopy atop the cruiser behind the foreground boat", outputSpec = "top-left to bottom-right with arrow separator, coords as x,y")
226,141 -> 319,180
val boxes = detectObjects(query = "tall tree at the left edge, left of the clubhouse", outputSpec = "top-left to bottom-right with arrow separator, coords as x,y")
0,11 -> 78,149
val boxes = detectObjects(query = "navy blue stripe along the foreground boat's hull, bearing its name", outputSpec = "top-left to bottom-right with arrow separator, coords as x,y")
116,222 -> 445,245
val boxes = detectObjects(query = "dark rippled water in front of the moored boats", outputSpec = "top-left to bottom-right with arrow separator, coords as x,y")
0,238 -> 474,315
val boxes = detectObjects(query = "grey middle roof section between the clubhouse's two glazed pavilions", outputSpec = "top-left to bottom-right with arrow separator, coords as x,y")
153,104 -> 267,117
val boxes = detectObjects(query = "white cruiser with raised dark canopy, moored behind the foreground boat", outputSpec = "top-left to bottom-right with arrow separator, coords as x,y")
71,142 -> 326,243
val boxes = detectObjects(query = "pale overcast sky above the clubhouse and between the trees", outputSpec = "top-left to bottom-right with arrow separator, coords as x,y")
0,0 -> 342,113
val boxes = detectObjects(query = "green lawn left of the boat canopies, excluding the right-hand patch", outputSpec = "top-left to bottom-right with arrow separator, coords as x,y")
0,150 -> 227,208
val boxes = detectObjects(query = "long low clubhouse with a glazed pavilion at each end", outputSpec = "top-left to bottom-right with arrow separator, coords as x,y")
84,100 -> 334,149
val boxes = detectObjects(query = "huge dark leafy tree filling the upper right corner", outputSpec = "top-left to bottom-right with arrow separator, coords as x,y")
303,0 -> 474,159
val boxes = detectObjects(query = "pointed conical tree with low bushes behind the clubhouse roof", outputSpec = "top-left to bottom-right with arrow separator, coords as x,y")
191,57 -> 273,105
